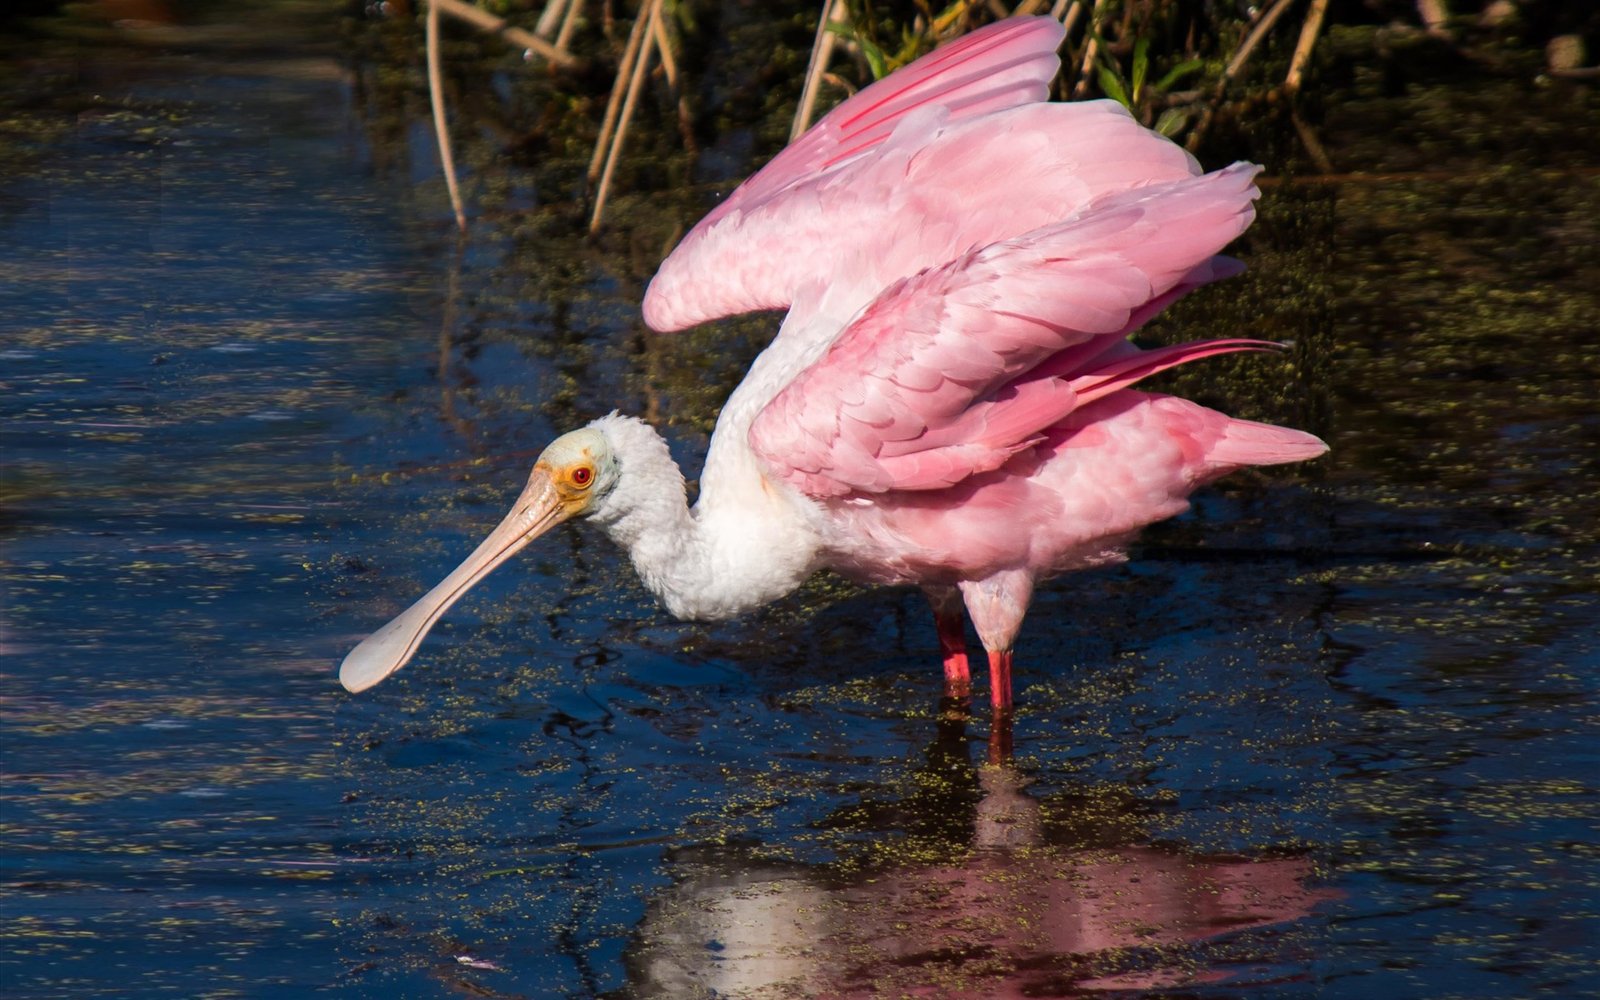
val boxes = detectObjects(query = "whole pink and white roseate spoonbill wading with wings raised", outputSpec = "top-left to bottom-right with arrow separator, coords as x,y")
339,18 -> 1326,717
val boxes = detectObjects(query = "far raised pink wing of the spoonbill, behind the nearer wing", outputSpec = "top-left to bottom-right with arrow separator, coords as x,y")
643,19 -> 1200,330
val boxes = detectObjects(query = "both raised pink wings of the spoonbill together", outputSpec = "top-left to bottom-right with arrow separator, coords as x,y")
645,19 -> 1324,547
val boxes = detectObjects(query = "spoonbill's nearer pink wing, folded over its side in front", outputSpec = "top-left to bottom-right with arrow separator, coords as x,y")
749,163 -> 1261,496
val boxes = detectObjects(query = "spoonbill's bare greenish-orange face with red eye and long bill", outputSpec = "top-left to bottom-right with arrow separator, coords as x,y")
339,416 -> 624,691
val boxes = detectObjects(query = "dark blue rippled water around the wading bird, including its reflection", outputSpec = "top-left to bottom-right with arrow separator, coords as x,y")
0,3 -> 1600,997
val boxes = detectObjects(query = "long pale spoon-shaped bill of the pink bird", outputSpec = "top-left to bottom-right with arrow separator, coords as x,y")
339,472 -> 568,691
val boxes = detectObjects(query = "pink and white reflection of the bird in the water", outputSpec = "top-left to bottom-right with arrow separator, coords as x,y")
627,706 -> 1330,997
